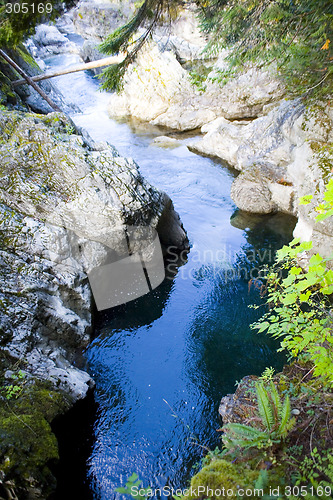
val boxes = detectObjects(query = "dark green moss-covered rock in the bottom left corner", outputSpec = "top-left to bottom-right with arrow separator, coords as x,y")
0,356 -> 71,498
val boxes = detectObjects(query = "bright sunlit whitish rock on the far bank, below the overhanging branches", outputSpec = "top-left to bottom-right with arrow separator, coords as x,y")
109,42 -> 283,131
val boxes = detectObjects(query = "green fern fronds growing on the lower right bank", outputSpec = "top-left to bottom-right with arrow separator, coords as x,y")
222,381 -> 295,450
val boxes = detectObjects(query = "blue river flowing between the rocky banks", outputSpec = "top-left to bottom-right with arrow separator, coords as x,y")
46,50 -> 294,500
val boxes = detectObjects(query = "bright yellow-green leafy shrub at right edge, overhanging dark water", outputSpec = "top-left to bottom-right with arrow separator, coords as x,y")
252,239 -> 333,386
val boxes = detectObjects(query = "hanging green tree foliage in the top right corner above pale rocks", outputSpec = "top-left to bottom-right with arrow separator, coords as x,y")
199,0 -> 333,97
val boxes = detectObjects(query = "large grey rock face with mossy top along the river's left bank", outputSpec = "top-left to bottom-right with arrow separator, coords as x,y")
0,110 -> 188,399
